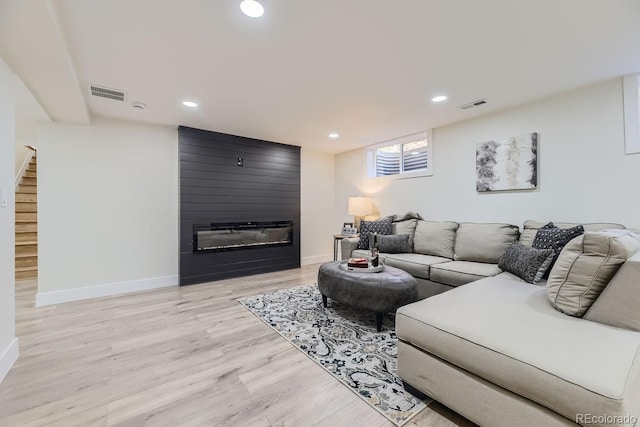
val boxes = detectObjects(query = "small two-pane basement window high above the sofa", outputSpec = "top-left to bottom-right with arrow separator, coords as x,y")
366,132 -> 433,179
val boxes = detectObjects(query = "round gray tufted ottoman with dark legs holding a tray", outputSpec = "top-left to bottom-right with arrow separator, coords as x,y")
318,261 -> 418,332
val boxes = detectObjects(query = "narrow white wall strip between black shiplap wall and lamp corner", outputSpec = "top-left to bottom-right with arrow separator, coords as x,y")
300,149 -> 339,265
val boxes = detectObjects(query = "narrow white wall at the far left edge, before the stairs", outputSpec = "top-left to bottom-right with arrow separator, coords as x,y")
0,58 -> 18,381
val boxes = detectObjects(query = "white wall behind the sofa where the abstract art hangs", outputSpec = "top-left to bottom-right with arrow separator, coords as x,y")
336,79 -> 640,227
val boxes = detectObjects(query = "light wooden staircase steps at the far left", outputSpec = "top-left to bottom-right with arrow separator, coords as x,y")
16,155 -> 38,280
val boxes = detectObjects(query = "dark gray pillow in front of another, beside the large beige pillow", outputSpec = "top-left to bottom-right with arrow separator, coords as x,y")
498,242 -> 555,285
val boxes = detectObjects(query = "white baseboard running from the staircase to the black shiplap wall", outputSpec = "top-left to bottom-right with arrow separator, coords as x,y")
36,276 -> 178,307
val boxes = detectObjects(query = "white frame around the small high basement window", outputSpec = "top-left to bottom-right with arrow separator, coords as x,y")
365,129 -> 433,180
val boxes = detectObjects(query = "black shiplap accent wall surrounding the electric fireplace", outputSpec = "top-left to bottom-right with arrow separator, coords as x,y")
178,126 -> 300,285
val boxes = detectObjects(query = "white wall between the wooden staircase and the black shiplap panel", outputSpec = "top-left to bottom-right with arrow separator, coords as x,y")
36,118 -> 179,305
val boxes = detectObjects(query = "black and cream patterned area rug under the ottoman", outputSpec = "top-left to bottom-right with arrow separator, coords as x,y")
238,285 -> 429,426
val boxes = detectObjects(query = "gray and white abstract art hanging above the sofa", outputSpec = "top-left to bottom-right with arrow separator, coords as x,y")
476,133 -> 538,192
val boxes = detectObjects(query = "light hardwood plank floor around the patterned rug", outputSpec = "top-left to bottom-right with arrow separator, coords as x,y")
0,265 -> 472,427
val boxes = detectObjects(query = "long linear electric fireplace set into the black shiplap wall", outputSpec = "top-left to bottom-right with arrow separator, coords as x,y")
193,221 -> 293,252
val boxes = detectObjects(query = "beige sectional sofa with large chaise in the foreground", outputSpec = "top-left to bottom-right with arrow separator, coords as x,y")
343,220 -> 640,426
